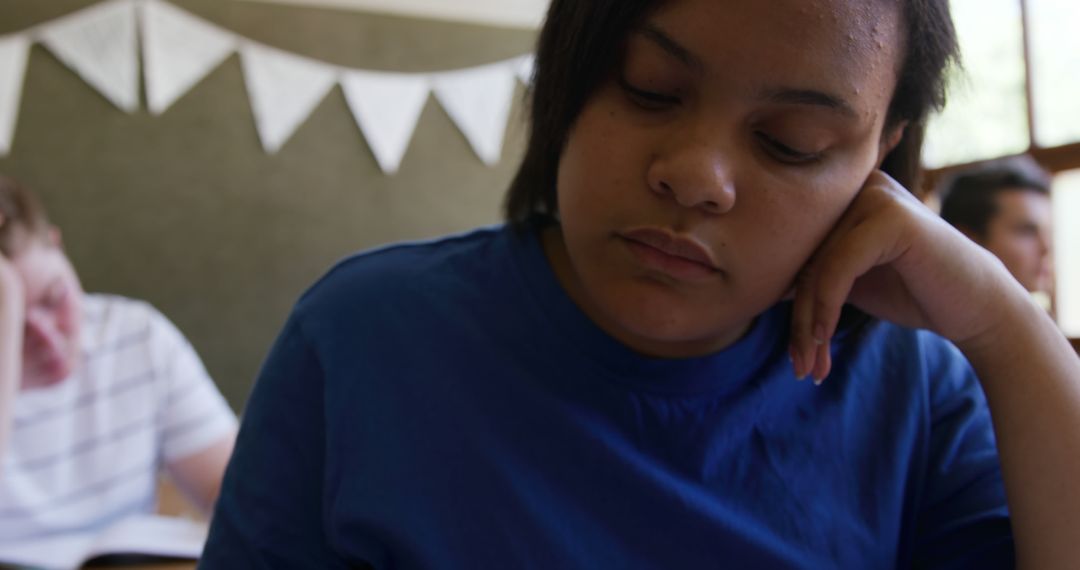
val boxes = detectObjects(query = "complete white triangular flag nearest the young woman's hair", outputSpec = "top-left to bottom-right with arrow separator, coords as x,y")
434,60 -> 515,166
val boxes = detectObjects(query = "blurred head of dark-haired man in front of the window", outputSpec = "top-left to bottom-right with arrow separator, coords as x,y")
942,157 -> 1054,310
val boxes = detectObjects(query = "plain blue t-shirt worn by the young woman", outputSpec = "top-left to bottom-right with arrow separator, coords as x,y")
201,228 -> 1013,570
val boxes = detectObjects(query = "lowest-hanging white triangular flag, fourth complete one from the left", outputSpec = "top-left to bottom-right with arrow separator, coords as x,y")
341,71 -> 431,174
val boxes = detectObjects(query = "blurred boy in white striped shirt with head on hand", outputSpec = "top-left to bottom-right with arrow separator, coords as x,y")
0,176 -> 237,548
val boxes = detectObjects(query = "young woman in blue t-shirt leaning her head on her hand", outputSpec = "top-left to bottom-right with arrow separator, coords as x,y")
202,0 -> 1080,569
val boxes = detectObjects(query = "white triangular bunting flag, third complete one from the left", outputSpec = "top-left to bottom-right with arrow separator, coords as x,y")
240,43 -> 337,153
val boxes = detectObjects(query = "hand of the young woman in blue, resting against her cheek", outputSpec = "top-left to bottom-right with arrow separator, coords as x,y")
791,171 -> 1027,381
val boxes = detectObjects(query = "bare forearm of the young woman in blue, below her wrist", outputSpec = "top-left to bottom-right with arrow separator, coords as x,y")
960,291 -> 1080,569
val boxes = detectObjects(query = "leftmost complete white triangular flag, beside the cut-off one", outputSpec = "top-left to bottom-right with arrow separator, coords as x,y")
40,0 -> 138,112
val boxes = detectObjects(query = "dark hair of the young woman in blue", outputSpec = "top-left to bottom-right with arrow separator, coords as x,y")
503,0 -> 959,227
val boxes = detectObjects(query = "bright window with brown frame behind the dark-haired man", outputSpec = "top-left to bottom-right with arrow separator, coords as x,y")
916,0 -> 1080,338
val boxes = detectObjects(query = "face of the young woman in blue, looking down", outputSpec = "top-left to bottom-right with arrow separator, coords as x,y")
543,0 -> 903,357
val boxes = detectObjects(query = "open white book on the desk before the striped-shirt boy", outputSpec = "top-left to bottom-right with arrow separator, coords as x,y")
0,515 -> 207,570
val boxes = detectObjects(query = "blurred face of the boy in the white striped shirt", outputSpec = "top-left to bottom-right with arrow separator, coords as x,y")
11,241 -> 82,390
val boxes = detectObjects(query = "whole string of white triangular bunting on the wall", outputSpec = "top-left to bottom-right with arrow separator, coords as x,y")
0,0 -> 532,174
